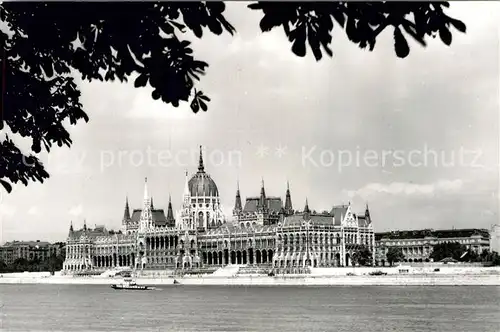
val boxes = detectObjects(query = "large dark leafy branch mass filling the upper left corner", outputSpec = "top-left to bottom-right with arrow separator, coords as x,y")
0,2 -> 235,192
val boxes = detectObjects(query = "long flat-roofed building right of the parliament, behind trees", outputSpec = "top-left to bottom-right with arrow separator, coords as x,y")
375,228 -> 490,265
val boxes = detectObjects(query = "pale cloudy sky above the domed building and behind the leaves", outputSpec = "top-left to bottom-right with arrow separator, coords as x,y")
0,2 -> 500,243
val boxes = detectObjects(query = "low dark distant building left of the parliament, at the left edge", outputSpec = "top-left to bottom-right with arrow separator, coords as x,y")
0,240 -> 63,264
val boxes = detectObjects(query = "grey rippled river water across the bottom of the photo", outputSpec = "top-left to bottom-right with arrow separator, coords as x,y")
0,285 -> 500,332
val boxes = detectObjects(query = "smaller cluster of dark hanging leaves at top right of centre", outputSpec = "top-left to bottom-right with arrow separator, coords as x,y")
248,1 -> 466,61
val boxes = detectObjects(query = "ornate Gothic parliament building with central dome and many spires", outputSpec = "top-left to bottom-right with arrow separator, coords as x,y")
63,148 -> 375,273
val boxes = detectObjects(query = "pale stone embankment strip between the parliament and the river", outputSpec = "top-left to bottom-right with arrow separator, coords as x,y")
0,274 -> 500,286
